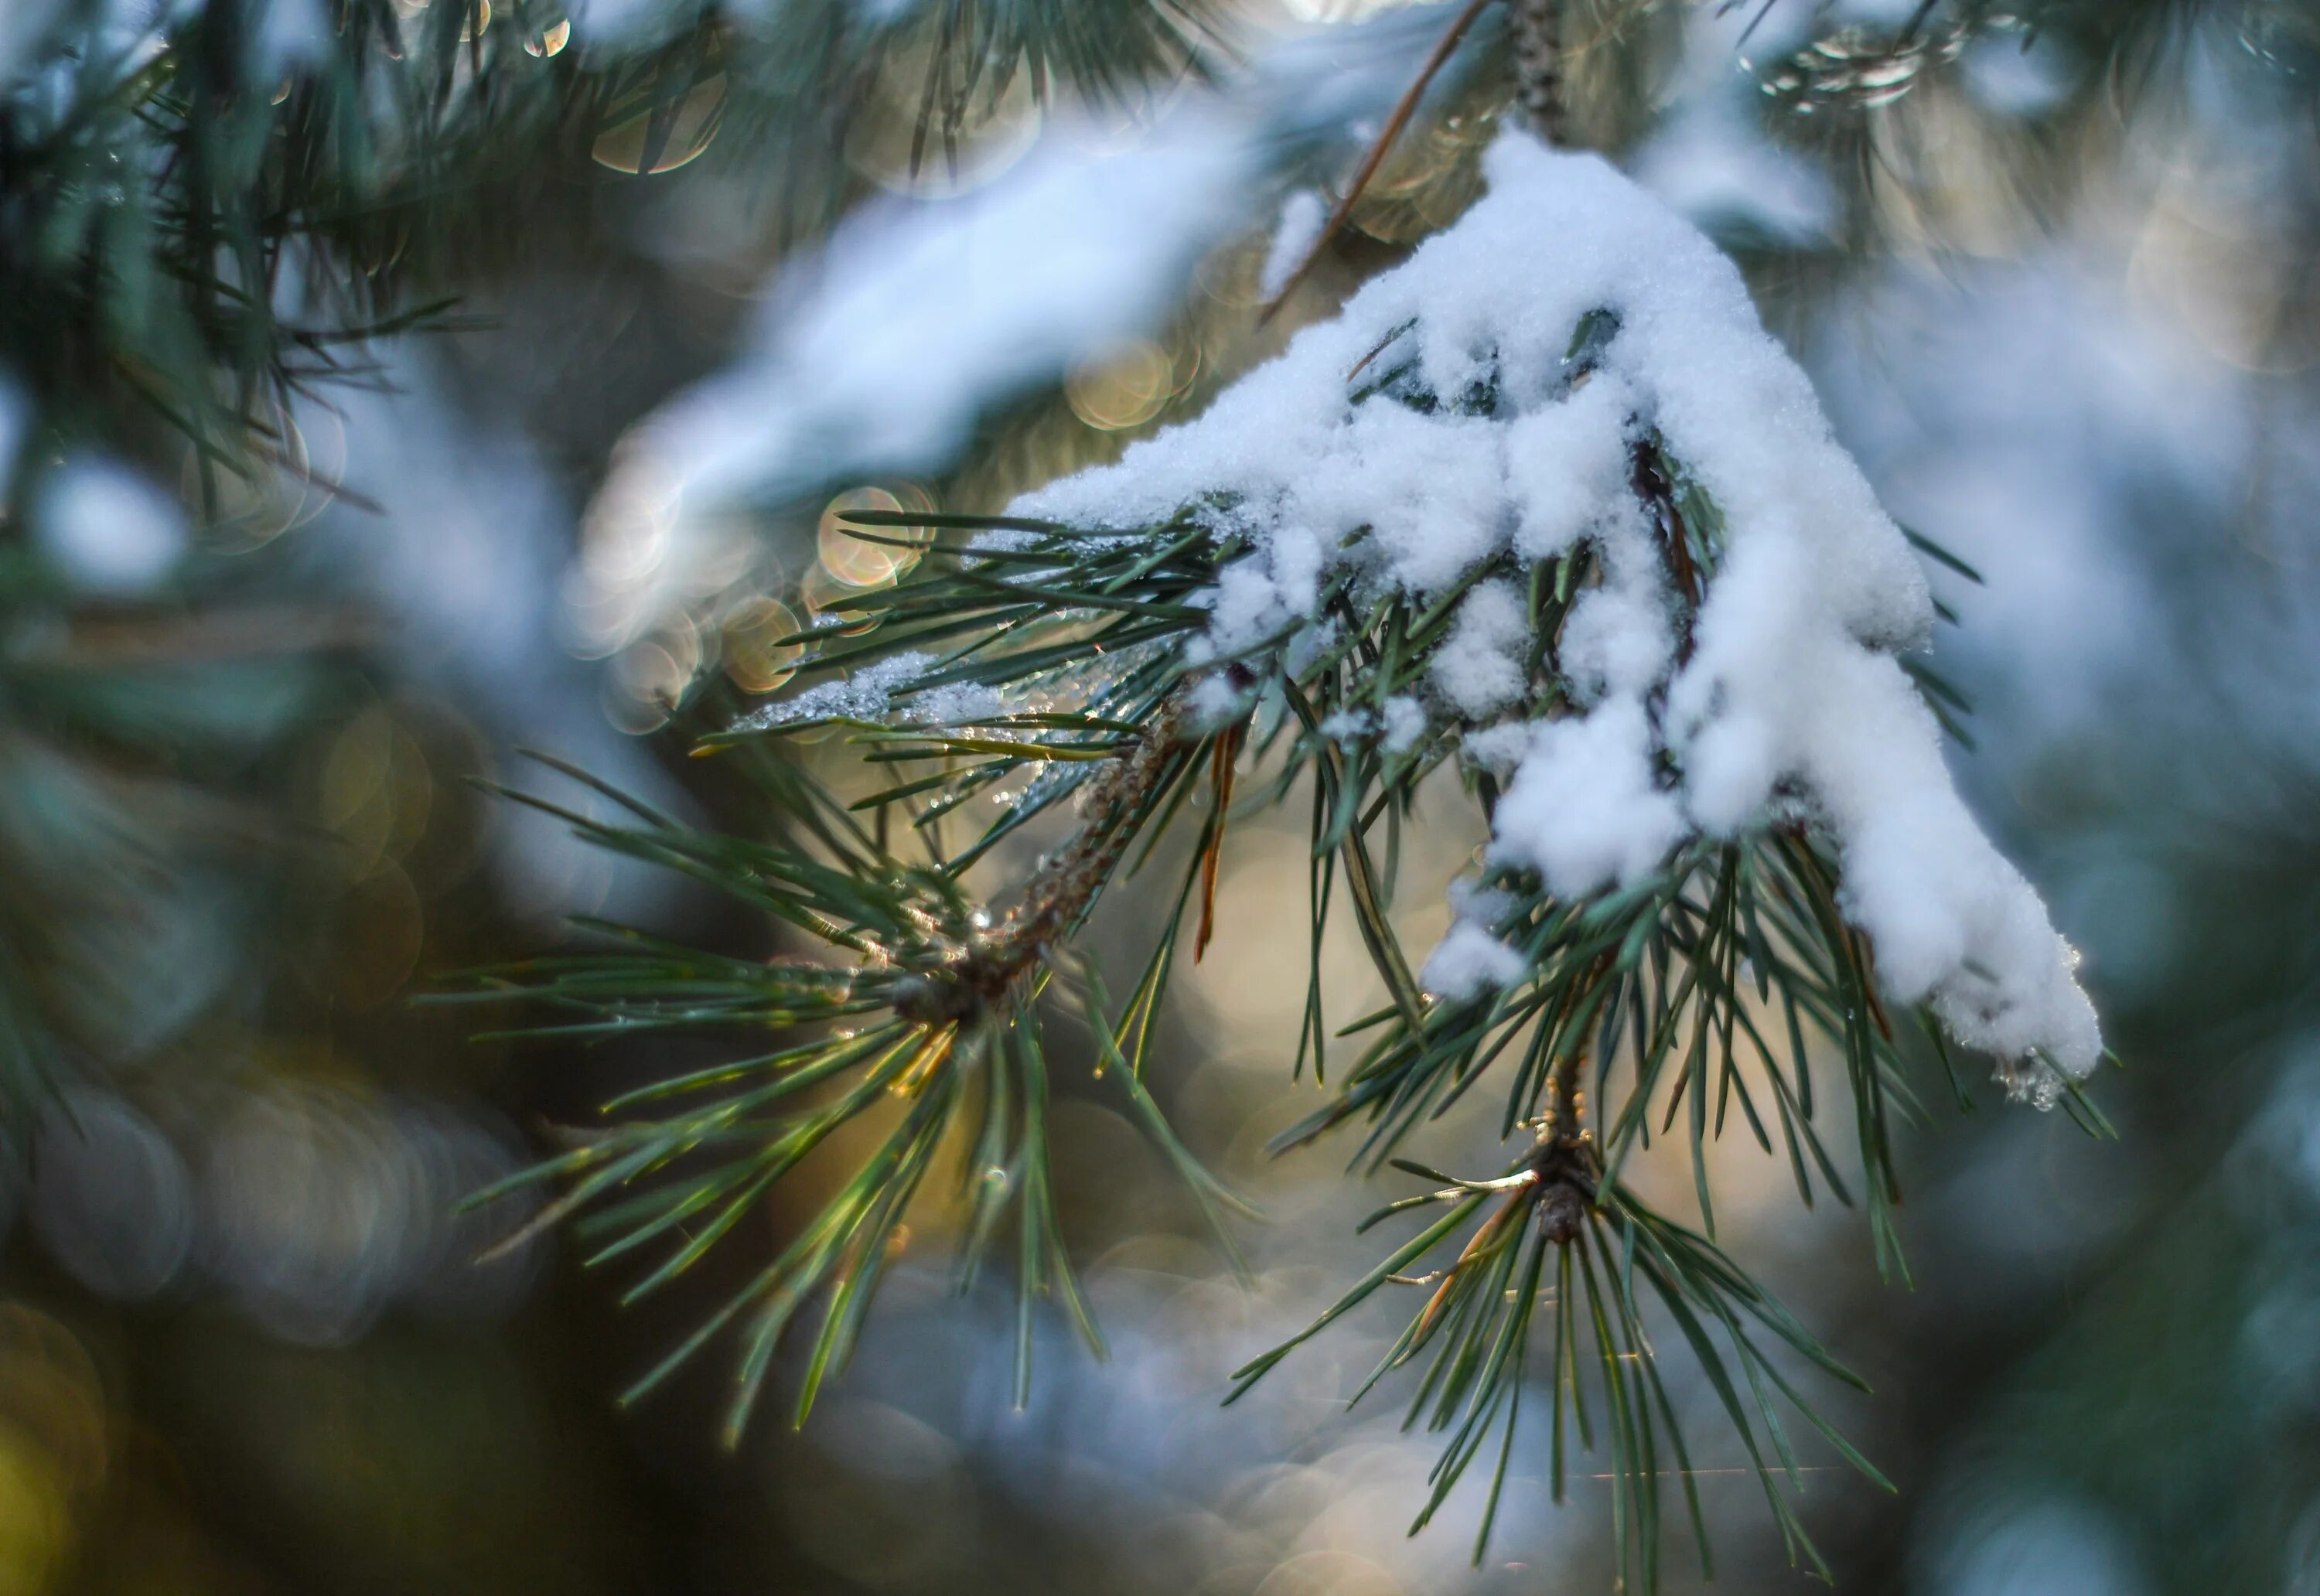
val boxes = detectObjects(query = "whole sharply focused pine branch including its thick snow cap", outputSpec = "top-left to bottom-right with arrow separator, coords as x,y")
485,121 -> 2102,1589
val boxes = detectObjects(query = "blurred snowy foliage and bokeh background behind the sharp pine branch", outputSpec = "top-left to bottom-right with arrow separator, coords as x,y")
0,0 -> 2320,1596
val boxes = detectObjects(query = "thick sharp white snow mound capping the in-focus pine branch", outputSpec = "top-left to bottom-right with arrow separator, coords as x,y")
1009,135 -> 2102,1097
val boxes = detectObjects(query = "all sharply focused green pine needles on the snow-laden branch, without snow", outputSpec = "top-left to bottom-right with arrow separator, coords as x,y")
443,309 -> 2102,1589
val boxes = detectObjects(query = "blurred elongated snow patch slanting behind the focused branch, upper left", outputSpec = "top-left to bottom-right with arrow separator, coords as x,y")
564,0 -> 1441,654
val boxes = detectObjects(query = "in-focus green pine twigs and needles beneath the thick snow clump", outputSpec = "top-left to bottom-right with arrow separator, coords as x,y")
466,383 -> 2032,1577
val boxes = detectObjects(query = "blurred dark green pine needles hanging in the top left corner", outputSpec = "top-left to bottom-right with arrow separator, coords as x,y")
0,0 -> 1216,480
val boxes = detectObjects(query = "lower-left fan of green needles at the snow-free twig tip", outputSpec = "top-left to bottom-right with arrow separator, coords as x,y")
441,717 -> 1248,1441
